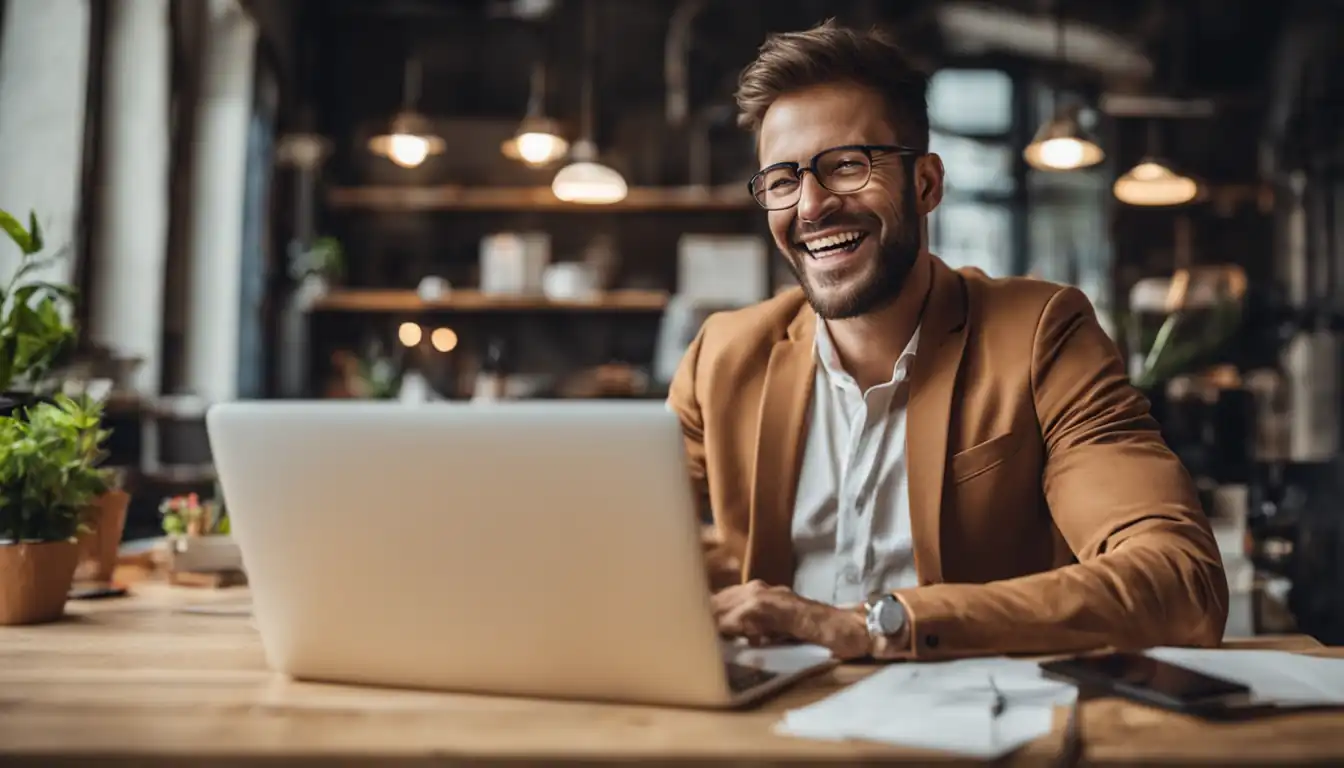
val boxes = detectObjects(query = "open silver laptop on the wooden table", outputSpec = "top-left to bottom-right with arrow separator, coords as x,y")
207,401 -> 836,707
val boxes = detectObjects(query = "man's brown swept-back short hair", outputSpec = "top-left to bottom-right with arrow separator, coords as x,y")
737,19 -> 929,149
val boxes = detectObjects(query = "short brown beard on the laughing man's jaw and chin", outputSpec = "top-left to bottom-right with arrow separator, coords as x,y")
784,191 -> 919,320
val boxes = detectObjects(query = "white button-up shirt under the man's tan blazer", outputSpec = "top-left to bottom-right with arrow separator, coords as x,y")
792,317 -> 919,605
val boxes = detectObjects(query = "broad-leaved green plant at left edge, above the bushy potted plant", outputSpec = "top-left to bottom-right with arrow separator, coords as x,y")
0,210 -> 75,414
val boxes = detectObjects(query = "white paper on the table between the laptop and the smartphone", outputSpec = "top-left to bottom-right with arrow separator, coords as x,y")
777,658 -> 1077,759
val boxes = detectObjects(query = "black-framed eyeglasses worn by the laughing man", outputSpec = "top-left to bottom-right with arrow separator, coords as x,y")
747,144 -> 923,211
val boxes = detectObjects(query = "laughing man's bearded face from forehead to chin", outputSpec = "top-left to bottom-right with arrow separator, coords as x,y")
759,85 -> 941,320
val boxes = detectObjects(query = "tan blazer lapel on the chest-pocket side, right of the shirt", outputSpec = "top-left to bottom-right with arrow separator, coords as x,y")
906,257 -> 969,584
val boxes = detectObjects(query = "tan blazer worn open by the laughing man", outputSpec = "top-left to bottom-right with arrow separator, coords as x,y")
668,257 -> 1227,658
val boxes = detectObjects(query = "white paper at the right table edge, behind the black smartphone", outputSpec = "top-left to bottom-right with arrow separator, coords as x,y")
1146,648 -> 1344,706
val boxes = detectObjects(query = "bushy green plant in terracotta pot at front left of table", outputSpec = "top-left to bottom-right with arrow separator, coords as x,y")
0,394 -> 112,624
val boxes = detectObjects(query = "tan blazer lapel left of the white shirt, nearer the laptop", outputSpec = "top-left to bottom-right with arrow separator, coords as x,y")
743,305 -> 816,585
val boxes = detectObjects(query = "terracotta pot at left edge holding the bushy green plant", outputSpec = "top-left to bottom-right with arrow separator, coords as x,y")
0,541 -> 79,625
